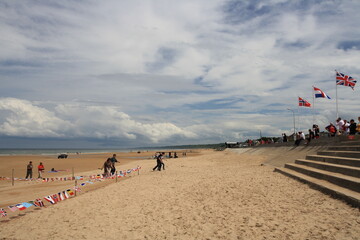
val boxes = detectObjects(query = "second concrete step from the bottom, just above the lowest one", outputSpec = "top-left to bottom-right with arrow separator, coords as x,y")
285,163 -> 360,192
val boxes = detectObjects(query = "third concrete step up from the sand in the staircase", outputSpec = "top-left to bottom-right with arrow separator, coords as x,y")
295,159 -> 360,178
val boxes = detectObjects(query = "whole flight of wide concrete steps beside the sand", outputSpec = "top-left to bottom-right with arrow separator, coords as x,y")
275,140 -> 360,208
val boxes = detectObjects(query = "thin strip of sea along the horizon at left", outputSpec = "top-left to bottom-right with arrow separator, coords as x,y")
0,148 -> 131,156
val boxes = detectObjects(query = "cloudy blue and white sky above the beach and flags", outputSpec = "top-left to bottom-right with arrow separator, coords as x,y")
0,0 -> 360,148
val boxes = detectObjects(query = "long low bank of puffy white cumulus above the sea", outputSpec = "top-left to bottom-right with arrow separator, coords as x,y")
0,98 -> 196,143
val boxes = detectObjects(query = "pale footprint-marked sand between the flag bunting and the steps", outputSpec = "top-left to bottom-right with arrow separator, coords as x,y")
0,148 -> 360,240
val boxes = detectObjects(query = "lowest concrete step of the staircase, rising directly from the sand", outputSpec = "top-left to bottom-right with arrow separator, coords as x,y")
275,168 -> 360,208
